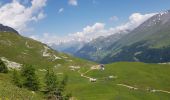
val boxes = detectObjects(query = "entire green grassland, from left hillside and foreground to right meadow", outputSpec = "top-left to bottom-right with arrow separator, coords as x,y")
0,33 -> 170,100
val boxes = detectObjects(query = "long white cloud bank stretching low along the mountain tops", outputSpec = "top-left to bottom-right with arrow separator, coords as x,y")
31,13 -> 156,44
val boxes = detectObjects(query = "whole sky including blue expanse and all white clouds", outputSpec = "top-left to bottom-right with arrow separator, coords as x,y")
0,0 -> 170,44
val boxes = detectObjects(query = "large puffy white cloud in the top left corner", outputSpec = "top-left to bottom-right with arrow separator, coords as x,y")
0,0 -> 47,32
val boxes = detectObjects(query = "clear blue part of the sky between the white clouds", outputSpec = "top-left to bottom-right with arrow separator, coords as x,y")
32,0 -> 170,35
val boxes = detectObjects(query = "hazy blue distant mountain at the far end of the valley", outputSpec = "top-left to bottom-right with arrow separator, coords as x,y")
74,33 -> 126,62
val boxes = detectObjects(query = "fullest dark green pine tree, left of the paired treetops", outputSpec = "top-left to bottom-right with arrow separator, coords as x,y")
21,65 -> 39,91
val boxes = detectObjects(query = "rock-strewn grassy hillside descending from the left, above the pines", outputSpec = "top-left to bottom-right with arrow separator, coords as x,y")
0,32 -> 94,68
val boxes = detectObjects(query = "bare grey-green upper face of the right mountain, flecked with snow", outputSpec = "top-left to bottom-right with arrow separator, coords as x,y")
111,11 -> 170,47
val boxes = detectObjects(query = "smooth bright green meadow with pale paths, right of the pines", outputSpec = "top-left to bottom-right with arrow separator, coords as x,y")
68,62 -> 170,100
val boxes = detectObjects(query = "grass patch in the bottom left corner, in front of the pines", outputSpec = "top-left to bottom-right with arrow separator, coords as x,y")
0,73 -> 44,100
